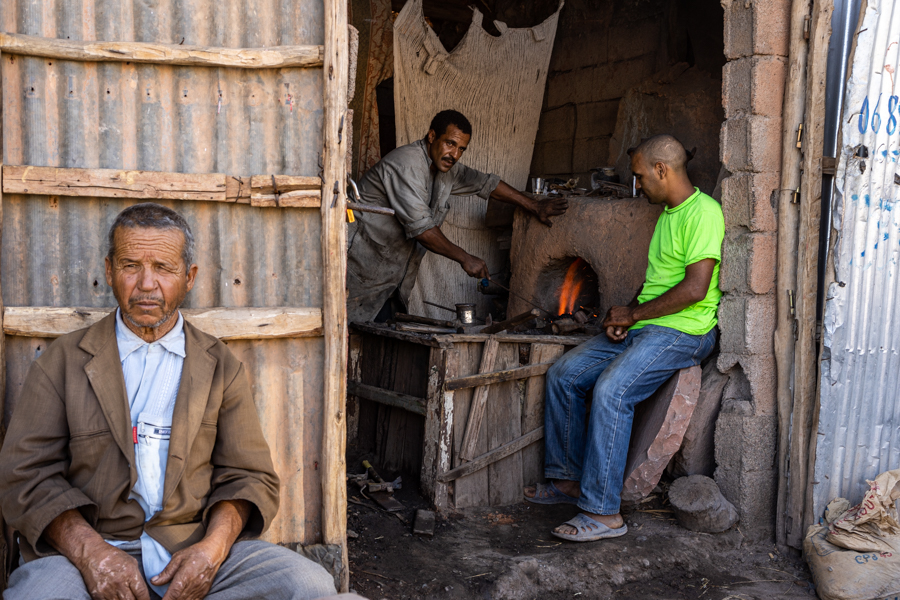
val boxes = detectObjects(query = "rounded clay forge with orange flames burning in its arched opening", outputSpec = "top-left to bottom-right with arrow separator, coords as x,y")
507,196 -> 661,317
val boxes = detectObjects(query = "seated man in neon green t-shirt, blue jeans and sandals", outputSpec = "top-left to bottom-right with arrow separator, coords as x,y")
525,135 -> 725,542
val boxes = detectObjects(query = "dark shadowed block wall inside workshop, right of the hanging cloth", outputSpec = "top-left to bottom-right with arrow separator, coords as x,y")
531,0 -> 724,185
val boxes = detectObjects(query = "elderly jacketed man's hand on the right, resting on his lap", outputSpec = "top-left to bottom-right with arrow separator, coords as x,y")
150,539 -> 227,600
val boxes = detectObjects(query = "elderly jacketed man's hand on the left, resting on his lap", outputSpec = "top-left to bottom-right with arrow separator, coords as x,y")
74,540 -> 150,600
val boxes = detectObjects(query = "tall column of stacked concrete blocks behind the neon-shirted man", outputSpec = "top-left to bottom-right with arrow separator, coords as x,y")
715,0 -> 790,537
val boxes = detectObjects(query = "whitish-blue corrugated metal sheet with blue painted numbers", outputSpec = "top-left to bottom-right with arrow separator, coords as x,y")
813,0 -> 900,515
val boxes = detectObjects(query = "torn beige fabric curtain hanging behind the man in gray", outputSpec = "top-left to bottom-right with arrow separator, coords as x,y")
394,0 -> 563,318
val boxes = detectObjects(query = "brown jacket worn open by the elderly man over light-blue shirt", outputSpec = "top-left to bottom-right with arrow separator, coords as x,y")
0,313 -> 278,560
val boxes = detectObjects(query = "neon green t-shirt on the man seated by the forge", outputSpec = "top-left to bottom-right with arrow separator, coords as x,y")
630,188 -> 725,335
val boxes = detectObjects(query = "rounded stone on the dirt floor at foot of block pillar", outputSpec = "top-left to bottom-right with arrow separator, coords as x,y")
669,475 -> 738,533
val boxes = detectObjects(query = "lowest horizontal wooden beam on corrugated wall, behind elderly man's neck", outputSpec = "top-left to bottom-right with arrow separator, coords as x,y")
3,306 -> 322,341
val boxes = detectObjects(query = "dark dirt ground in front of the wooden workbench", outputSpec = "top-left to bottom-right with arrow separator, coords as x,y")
348,474 -> 815,600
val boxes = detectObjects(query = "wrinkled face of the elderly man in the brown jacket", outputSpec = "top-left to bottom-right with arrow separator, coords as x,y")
106,227 -> 197,342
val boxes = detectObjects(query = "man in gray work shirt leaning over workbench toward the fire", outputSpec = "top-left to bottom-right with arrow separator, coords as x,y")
347,110 -> 568,321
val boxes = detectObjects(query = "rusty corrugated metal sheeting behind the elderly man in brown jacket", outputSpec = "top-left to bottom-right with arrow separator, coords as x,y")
0,0 -> 324,544
